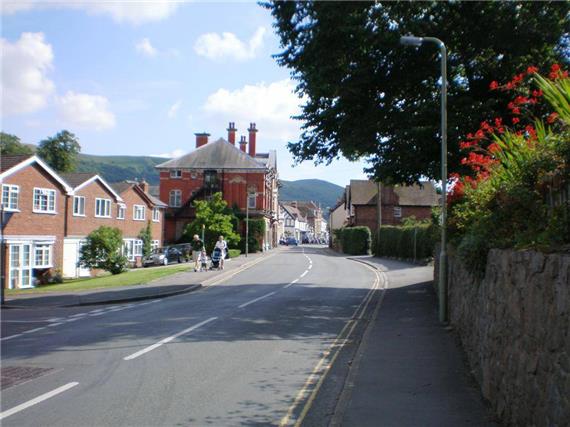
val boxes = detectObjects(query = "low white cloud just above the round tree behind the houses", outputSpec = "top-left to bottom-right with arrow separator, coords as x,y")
56,91 -> 115,130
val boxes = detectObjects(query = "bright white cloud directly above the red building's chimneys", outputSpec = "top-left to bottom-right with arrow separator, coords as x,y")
203,79 -> 301,141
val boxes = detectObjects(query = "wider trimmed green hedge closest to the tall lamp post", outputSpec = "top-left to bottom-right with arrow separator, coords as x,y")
373,224 -> 437,259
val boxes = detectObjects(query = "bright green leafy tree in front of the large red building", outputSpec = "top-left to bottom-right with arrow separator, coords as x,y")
182,193 -> 240,250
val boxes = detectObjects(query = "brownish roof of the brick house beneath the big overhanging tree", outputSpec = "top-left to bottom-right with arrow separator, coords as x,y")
349,180 -> 439,206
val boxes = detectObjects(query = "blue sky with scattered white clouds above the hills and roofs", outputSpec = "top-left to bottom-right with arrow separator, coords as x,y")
0,0 -> 364,186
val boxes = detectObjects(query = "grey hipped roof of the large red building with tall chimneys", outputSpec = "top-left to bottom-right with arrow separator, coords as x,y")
156,138 -> 268,170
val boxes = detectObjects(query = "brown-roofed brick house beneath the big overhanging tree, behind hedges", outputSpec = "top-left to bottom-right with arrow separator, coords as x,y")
345,180 -> 439,231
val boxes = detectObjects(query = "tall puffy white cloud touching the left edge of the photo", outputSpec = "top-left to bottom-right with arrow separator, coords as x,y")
0,33 -> 55,114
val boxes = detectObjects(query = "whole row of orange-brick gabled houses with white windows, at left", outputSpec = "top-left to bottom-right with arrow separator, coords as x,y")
0,156 -> 166,288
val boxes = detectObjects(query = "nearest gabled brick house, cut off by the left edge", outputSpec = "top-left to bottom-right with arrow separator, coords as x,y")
0,156 -> 73,288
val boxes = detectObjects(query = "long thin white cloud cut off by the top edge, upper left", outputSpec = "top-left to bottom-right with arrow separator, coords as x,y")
2,0 -> 182,25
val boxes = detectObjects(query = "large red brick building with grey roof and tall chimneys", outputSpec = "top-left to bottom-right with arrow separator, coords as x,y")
156,122 -> 279,251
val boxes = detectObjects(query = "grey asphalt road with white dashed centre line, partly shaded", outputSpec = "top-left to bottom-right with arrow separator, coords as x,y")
0,247 -> 377,426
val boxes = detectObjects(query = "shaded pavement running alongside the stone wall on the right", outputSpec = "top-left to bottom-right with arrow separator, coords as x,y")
331,257 -> 495,427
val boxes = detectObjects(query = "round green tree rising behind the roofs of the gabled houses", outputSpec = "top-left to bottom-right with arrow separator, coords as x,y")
38,130 -> 81,172
